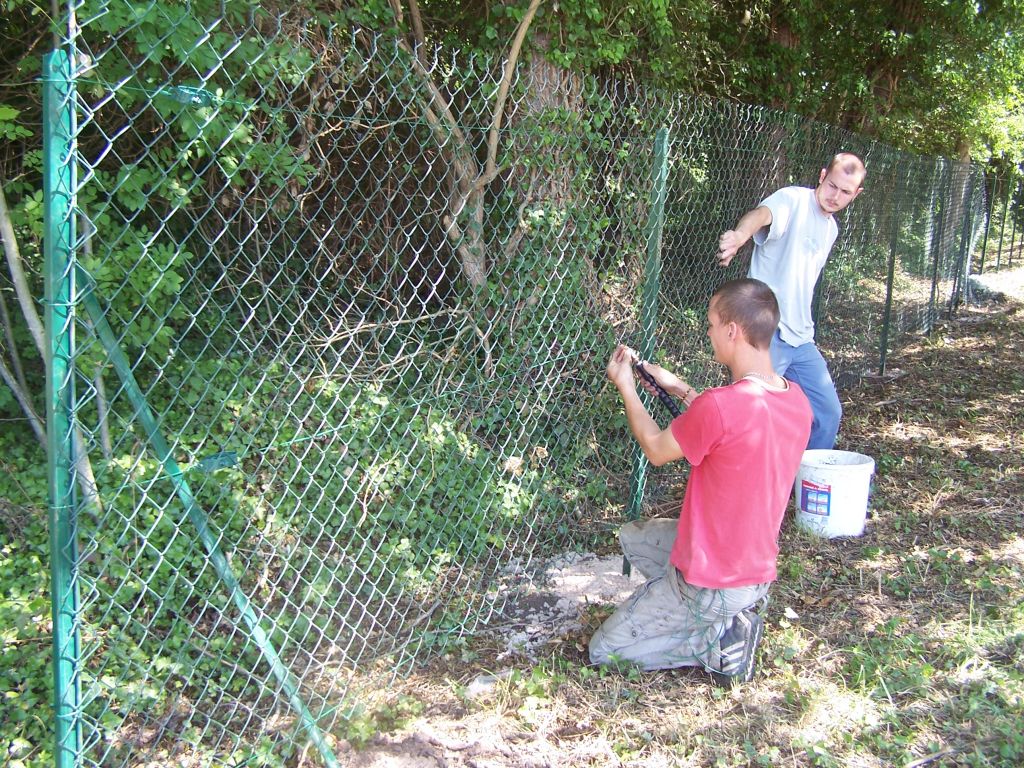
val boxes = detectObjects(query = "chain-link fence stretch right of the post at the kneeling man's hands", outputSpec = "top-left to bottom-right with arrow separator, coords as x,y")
630,115 -> 987,516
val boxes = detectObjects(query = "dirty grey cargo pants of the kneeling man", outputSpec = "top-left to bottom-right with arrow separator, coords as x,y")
590,518 -> 769,670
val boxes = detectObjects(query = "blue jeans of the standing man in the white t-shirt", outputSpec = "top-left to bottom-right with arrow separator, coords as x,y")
771,331 -> 843,451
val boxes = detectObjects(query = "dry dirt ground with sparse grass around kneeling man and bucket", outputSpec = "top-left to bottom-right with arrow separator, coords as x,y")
327,269 -> 1024,768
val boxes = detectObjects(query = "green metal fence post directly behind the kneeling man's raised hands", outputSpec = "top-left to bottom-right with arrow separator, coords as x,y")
623,128 -> 669,575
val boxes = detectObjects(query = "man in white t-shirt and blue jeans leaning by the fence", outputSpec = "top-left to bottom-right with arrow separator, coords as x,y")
718,153 -> 867,450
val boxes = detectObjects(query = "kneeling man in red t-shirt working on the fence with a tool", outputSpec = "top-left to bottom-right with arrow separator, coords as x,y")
590,279 -> 812,685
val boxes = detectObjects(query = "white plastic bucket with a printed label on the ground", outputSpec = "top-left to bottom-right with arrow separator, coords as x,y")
793,450 -> 874,539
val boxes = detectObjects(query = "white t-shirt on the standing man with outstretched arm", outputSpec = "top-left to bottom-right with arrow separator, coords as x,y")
748,186 -> 839,346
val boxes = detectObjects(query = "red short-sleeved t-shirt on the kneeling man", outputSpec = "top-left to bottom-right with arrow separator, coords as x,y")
671,379 -> 812,589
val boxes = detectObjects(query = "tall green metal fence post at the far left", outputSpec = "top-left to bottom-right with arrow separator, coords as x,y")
42,46 -> 82,768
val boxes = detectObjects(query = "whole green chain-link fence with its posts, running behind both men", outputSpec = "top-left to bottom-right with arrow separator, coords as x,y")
0,2 -> 1006,766
